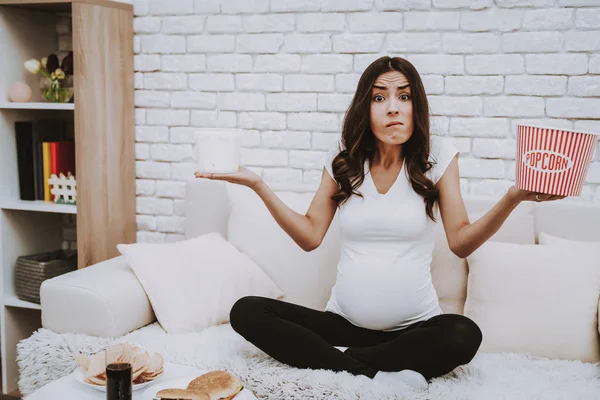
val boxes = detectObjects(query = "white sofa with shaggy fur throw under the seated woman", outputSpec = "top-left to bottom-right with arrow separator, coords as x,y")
28,180 -> 600,399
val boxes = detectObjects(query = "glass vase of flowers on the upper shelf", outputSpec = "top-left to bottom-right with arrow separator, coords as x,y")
25,51 -> 73,103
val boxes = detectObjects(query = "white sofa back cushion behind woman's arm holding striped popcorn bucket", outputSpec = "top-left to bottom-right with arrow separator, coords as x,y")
431,198 -> 535,314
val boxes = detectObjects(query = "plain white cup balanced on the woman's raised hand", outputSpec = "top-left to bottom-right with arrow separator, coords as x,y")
196,128 -> 244,174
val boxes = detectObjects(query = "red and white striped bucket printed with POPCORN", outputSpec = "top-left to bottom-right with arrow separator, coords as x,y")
515,125 -> 599,196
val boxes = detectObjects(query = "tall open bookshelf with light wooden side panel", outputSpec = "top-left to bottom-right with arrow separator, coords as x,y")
0,0 -> 136,394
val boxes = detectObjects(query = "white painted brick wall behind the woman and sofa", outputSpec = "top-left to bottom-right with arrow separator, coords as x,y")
126,0 -> 600,241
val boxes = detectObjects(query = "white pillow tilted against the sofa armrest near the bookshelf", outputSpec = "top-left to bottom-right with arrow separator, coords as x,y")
117,232 -> 283,333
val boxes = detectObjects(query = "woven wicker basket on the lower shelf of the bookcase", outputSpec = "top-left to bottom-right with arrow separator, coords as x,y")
15,250 -> 77,304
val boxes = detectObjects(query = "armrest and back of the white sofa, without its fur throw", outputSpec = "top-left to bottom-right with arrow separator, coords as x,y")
40,180 -> 600,350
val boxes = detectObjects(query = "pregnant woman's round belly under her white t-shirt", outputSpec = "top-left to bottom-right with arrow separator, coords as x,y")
333,260 -> 438,330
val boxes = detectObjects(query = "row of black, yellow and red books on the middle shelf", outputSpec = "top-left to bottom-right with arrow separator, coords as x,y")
15,120 -> 76,201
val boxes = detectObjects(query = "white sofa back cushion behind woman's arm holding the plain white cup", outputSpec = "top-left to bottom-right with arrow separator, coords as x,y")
228,185 -> 340,310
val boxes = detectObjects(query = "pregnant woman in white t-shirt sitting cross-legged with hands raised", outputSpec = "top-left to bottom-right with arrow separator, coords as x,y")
196,57 -> 562,391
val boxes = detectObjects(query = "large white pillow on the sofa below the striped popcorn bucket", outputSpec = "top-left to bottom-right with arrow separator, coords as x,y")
465,242 -> 600,362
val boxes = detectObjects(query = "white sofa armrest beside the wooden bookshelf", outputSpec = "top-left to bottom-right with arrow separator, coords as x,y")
40,256 -> 156,337
